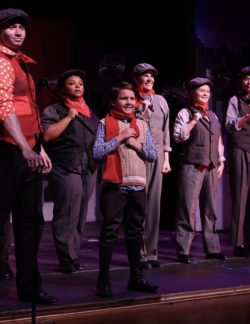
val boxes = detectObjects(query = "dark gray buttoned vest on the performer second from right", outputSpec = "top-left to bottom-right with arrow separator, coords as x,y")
181,111 -> 221,168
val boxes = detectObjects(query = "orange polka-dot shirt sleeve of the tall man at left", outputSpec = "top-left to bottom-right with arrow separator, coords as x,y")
0,57 -> 15,121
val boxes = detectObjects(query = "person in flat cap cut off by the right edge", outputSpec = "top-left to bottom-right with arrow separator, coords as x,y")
226,66 -> 250,257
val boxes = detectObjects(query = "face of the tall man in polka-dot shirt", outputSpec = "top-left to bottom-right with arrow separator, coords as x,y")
0,23 -> 26,50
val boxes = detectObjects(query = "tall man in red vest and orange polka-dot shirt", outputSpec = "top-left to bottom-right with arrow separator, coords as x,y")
0,8 -> 57,304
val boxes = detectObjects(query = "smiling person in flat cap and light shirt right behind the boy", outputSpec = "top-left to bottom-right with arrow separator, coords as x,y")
132,63 -> 171,269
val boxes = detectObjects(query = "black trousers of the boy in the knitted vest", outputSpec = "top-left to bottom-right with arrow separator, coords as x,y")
99,182 -> 146,282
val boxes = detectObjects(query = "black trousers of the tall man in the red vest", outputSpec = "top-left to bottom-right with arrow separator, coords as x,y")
0,142 -> 44,295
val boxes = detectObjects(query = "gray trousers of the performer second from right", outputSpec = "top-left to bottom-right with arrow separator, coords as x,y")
176,163 -> 220,255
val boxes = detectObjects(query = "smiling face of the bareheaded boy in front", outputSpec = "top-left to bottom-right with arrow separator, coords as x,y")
113,89 -> 136,115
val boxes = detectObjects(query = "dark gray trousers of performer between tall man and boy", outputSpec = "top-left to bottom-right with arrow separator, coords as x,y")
50,165 -> 91,264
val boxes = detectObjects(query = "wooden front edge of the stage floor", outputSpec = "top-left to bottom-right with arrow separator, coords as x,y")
0,285 -> 250,324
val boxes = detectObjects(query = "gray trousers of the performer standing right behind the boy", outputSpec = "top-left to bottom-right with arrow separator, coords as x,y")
141,150 -> 163,261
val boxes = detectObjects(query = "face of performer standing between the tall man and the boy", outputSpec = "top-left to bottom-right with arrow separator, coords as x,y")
61,75 -> 84,99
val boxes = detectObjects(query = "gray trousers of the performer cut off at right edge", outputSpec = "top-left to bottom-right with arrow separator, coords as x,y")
230,148 -> 250,246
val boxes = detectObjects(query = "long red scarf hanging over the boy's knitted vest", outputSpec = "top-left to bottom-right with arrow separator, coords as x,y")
103,110 -> 140,183
